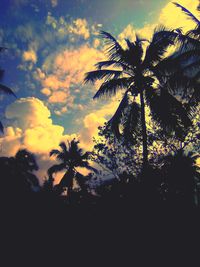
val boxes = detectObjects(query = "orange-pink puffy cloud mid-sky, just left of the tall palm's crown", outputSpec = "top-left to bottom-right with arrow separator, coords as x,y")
38,44 -> 104,108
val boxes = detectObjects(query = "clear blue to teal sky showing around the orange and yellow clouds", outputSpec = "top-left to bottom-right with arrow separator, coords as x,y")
0,0 -> 167,132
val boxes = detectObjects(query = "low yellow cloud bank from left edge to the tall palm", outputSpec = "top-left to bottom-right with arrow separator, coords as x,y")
0,97 -> 119,182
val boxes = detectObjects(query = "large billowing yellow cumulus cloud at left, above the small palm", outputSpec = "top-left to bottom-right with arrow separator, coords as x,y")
0,97 -> 76,184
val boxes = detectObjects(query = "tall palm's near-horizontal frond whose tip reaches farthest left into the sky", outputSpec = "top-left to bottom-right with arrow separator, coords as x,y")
84,70 -> 122,83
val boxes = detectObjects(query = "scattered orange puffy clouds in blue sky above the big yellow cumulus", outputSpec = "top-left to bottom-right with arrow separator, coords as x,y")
15,12 -> 104,115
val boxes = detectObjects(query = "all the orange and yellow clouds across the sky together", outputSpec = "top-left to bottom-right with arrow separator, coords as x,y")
0,0 -> 198,181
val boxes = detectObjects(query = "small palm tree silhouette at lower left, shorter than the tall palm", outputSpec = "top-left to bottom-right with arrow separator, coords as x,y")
48,139 -> 96,199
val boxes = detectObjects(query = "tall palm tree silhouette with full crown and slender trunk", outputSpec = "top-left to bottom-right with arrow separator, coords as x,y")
85,27 -> 191,167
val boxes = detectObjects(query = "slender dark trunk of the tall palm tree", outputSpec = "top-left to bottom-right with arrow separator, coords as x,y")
140,90 -> 148,168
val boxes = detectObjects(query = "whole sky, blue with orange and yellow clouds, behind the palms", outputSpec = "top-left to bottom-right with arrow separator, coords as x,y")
0,0 -> 199,182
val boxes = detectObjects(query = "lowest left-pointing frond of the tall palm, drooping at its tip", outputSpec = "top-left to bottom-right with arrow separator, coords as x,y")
93,78 -> 133,99
